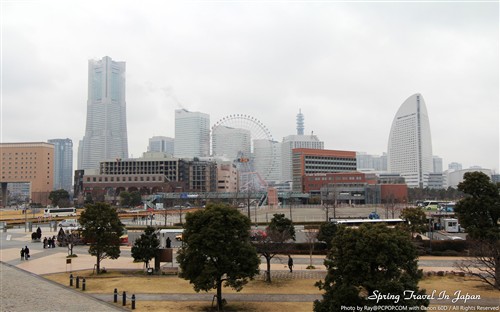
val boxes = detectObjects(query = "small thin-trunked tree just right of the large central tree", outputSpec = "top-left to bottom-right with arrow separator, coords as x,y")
254,214 -> 295,283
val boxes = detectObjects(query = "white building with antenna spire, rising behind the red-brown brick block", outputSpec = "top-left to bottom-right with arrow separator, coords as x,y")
281,110 -> 324,182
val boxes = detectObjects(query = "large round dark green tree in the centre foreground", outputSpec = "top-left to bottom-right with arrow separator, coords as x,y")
177,204 -> 260,309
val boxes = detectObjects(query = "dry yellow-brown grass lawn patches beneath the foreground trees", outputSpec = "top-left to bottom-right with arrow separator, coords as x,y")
44,271 -> 500,312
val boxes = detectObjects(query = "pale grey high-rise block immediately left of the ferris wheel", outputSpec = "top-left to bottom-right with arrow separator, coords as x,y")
174,109 -> 210,158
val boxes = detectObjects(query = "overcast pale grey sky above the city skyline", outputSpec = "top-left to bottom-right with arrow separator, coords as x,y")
0,0 -> 499,172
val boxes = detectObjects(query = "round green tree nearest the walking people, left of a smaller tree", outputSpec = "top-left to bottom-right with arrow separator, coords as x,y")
79,203 -> 124,274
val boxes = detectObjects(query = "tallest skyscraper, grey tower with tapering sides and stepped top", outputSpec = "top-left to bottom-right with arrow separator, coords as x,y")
78,56 -> 128,169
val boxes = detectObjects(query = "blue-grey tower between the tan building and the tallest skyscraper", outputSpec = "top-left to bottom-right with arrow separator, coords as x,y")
48,139 -> 73,193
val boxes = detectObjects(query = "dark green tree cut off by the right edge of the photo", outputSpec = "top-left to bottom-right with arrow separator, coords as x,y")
455,171 -> 500,289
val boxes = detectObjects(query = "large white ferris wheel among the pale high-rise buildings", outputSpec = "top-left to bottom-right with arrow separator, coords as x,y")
212,114 -> 279,191
